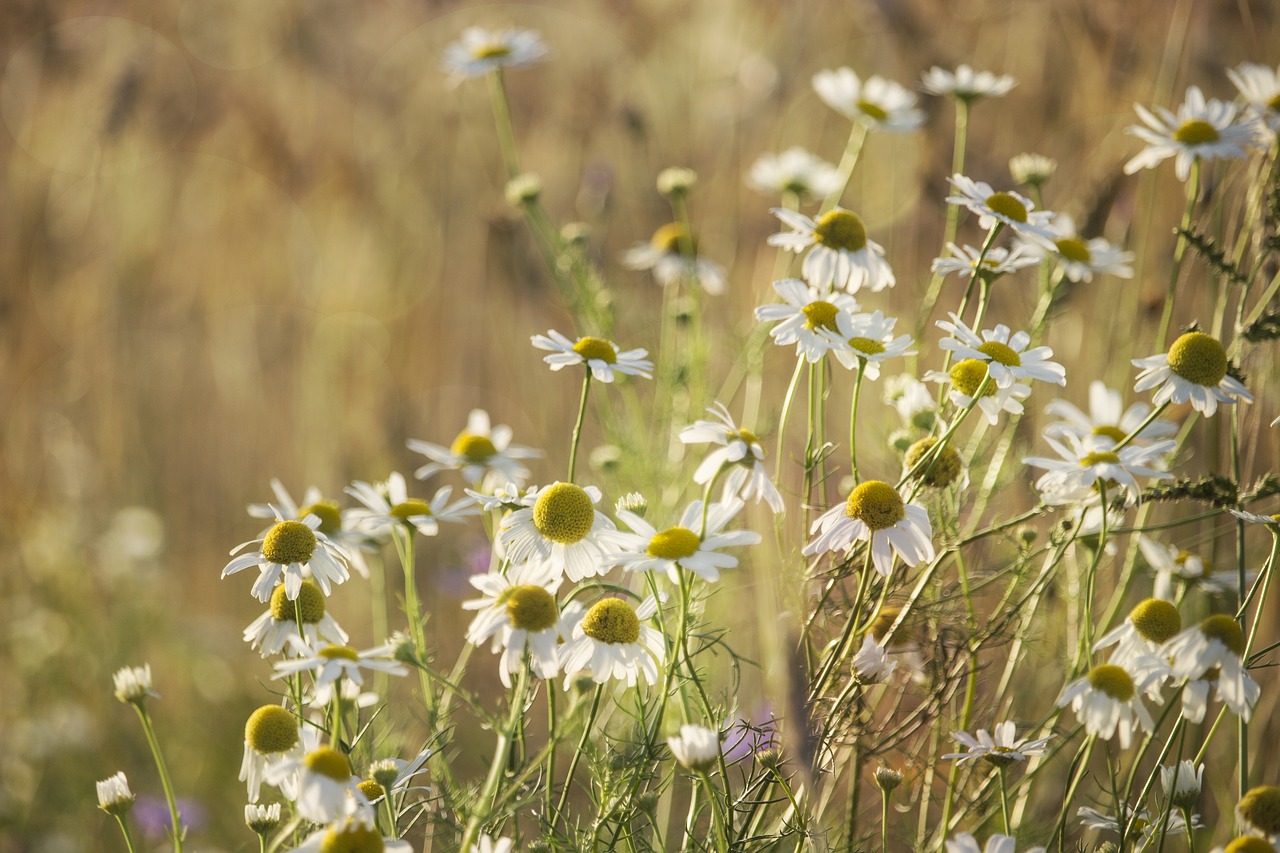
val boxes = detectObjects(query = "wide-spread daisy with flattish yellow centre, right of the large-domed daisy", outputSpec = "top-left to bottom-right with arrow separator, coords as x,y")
608,498 -> 760,584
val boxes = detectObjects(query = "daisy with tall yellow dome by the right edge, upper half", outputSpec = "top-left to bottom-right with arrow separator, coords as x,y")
1133,332 -> 1253,418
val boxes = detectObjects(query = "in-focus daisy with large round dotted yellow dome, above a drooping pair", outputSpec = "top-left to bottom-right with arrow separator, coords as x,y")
498,483 -> 617,583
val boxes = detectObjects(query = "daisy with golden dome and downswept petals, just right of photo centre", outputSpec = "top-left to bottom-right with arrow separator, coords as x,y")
803,480 -> 934,578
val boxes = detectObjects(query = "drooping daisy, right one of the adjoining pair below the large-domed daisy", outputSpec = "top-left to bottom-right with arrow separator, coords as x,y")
561,596 -> 667,690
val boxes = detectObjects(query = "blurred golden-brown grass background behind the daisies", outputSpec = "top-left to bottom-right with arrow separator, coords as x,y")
0,0 -> 1280,853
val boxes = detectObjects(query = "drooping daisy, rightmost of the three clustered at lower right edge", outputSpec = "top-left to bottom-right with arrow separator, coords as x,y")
1164,613 -> 1261,722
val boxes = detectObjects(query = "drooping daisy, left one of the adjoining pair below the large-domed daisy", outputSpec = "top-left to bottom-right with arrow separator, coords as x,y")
462,562 -> 567,688
